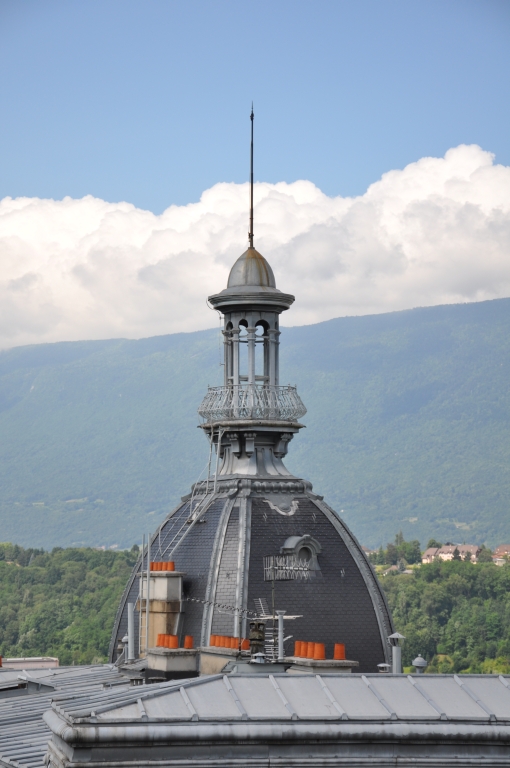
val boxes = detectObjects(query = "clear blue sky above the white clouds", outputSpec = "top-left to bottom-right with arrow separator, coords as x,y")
0,0 -> 510,213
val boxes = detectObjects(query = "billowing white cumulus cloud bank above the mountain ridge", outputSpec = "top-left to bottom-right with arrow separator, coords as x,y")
0,145 -> 510,348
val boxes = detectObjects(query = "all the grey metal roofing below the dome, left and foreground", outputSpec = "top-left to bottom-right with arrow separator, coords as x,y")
0,665 -> 510,768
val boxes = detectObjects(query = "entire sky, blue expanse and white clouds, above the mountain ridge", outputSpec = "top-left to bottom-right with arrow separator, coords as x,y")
0,0 -> 510,348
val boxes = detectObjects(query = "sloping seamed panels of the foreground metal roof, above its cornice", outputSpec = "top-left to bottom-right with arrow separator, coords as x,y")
53,674 -> 510,725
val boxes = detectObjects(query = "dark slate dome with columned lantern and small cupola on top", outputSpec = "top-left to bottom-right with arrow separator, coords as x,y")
110,247 -> 393,672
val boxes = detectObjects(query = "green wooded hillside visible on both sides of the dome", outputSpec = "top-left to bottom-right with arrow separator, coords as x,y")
0,544 -> 510,674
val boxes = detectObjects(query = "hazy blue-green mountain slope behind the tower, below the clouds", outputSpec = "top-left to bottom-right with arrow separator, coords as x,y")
0,299 -> 510,548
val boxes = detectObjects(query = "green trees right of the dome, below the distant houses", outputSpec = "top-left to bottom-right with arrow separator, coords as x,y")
381,560 -> 510,674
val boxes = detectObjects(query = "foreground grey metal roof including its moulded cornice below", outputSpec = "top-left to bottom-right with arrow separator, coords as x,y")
41,674 -> 510,768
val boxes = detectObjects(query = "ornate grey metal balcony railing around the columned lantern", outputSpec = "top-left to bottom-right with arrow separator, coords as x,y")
198,384 -> 306,423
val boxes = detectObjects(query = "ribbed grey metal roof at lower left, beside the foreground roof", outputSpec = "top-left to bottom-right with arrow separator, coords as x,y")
0,664 -> 129,768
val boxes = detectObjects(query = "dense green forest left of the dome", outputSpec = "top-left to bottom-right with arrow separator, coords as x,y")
0,544 -> 137,664
